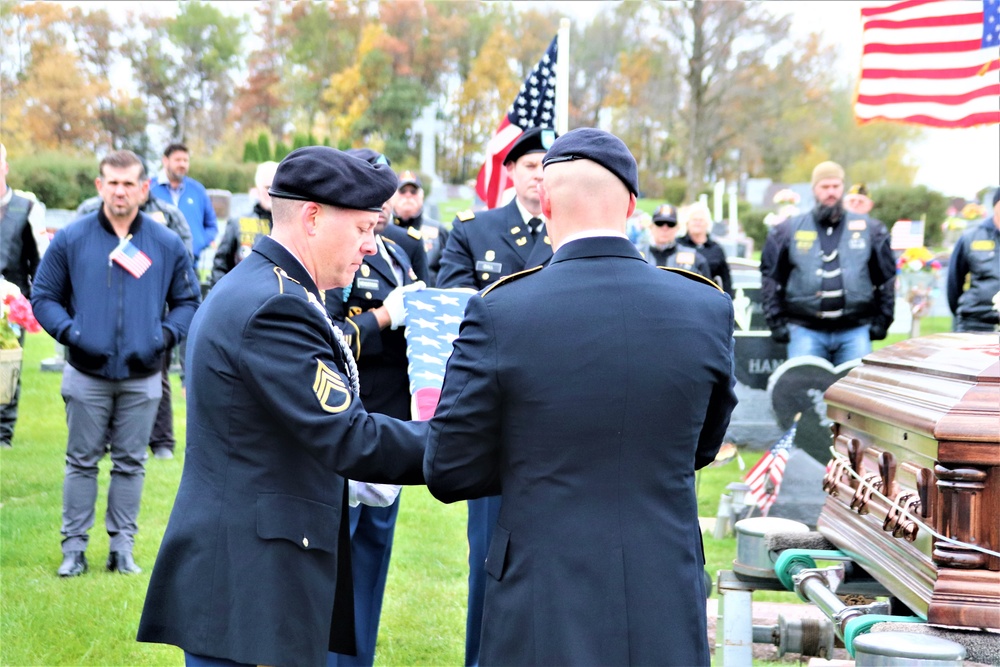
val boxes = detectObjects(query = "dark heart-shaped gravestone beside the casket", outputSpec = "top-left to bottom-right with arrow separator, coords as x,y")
767,356 -> 861,463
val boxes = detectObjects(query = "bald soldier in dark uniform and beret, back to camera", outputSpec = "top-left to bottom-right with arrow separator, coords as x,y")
424,128 -> 736,665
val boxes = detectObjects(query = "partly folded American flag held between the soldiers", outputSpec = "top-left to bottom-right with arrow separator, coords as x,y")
403,289 -> 475,420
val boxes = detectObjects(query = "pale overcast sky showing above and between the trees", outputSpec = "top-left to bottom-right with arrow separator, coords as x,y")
72,0 -> 1000,198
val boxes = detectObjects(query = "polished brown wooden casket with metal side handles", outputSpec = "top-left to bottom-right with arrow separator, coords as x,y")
817,334 -> 1000,631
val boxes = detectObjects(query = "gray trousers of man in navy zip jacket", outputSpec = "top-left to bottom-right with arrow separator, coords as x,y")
61,364 -> 161,553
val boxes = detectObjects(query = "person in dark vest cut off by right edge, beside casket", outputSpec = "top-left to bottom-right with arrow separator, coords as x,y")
948,187 -> 1000,331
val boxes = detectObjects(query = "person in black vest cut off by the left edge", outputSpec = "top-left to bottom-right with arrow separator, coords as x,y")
0,144 -> 42,449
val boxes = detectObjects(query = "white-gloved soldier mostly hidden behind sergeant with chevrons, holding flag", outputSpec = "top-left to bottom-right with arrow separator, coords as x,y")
326,148 -> 425,667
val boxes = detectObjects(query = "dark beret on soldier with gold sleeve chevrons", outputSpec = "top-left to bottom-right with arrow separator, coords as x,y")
268,146 -> 396,211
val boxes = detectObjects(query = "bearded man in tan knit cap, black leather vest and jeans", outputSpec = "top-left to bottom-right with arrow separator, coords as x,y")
760,162 -> 896,366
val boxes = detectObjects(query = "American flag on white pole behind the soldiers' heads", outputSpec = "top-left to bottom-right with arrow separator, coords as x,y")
476,36 -> 558,208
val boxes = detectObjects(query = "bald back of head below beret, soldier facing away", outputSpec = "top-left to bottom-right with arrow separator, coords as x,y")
539,160 -> 635,248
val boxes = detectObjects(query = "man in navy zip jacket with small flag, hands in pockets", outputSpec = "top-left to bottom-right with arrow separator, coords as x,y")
31,151 -> 201,577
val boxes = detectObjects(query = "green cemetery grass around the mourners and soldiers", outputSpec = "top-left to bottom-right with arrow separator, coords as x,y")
0,318 -> 950,666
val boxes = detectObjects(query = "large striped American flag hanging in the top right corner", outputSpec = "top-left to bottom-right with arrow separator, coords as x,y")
854,0 -> 1000,127
